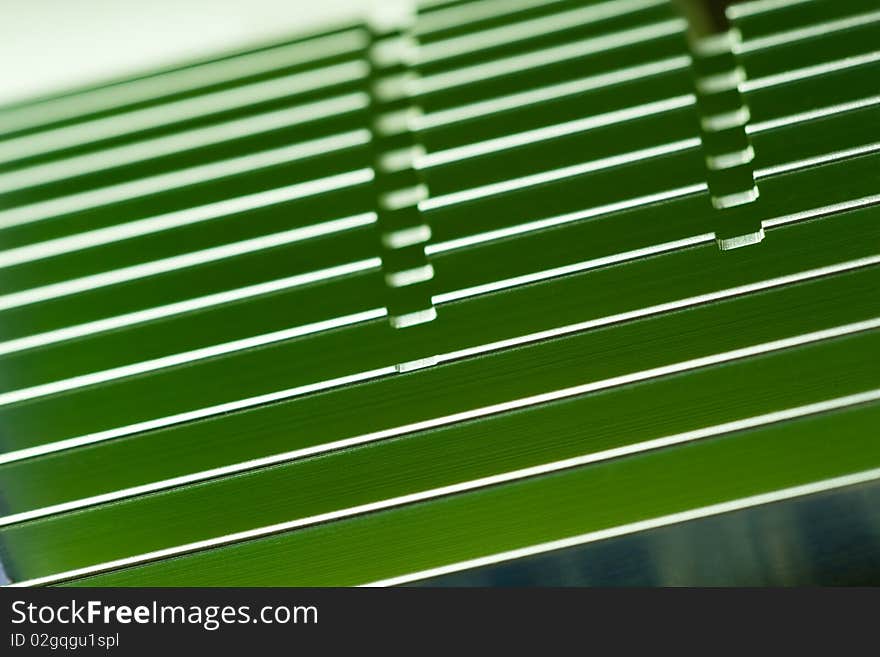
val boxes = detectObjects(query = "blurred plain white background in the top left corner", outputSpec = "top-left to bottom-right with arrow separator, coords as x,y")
0,0 -> 368,104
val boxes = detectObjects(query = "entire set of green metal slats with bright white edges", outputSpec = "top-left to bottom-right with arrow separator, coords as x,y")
0,0 -> 880,586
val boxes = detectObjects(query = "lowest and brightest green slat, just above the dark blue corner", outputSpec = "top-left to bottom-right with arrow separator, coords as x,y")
70,405 -> 880,586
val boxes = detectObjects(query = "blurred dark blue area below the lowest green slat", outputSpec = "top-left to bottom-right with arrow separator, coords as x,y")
416,476 -> 880,586
